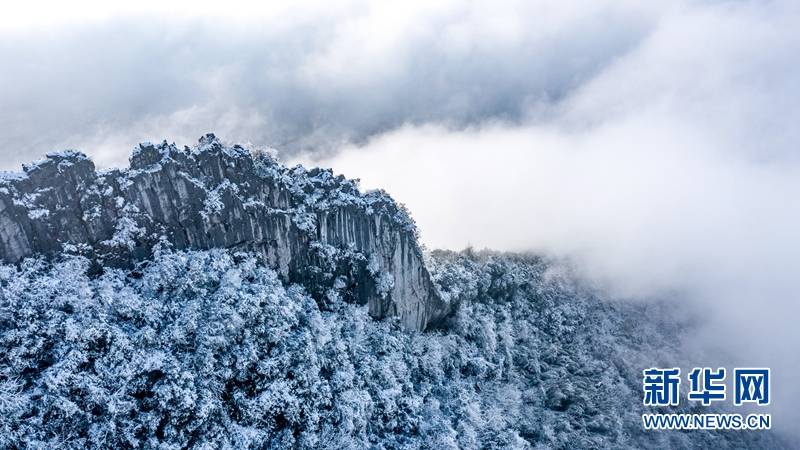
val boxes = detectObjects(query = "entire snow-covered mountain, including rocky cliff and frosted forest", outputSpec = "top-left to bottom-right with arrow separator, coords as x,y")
0,139 -> 785,449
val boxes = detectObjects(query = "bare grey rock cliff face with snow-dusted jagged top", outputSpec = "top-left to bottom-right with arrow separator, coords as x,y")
0,135 -> 449,330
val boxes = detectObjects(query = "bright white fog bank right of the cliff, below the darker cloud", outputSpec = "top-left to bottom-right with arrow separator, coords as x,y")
300,2 -> 800,433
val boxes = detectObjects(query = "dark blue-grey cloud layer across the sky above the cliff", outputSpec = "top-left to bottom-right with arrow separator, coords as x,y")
0,1 -> 664,169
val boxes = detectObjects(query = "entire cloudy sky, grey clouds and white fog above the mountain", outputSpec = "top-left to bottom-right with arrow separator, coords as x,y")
0,0 -> 800,438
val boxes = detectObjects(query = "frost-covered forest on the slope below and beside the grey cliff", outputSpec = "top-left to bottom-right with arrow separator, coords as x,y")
0,248 -> 775,449
